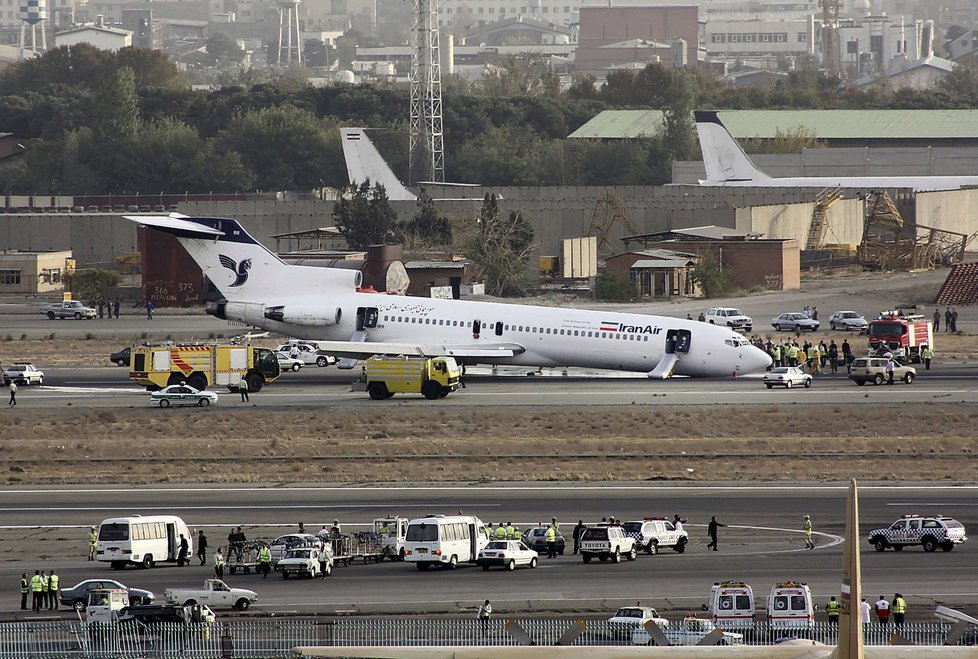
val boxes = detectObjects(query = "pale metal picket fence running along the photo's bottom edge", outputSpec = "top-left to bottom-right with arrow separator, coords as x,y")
0,618 -> 975,659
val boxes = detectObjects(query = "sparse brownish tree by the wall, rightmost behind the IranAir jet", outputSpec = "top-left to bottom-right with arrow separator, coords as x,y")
468,194 -> 536,296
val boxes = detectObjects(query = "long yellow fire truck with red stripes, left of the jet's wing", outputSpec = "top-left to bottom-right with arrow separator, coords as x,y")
129,343 -> 281,391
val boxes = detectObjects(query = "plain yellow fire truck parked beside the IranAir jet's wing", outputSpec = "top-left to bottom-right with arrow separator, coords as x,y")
355,357 -> 461,400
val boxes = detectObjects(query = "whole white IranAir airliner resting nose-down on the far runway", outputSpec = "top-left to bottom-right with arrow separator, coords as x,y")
126,214 -> 771,378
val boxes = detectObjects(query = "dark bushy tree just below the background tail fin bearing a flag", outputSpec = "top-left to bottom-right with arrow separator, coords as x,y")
333,180 -> 402,249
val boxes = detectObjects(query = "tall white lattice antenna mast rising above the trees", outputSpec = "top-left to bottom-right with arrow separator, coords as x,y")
408,0 -> 445,185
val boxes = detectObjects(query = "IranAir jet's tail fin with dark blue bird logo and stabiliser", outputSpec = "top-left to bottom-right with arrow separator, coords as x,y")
125,214 -> 362,301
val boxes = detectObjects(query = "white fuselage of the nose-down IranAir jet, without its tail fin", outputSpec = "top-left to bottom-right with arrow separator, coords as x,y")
217,292 -> 770,376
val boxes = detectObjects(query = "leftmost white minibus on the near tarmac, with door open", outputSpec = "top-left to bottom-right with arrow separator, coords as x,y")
95,515 -> 194,570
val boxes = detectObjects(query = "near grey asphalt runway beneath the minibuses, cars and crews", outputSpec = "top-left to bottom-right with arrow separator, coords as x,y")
0,484 -> 978,619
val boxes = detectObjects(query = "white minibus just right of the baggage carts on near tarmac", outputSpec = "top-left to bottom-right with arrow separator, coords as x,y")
404,515 -> 489,570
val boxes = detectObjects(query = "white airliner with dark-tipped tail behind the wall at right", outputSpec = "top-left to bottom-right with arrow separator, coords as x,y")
694,110 -> 978,192
